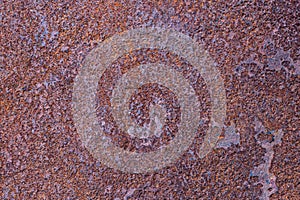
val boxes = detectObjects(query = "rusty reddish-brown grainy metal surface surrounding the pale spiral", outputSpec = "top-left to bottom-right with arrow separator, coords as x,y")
0,1 -> 300,199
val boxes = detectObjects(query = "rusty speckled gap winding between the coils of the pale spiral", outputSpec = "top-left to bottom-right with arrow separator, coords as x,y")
97,49 -> 210,151
